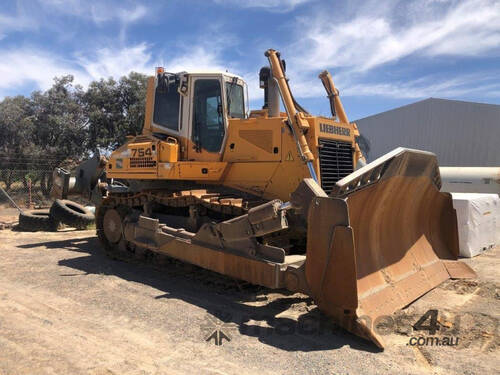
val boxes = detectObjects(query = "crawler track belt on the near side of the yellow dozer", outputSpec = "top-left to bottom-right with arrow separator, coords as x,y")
96,194 -> 294,293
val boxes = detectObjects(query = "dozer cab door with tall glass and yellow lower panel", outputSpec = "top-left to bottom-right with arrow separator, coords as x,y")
188,76 -> 226,161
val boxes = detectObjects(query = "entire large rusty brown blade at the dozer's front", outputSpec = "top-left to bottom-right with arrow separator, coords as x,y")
305,148 -> 475,348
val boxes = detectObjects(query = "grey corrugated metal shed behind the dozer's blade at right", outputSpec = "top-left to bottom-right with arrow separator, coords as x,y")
356,98 -> 500,167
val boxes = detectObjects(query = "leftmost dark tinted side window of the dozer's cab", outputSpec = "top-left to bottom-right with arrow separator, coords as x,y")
153,77 -> 180,131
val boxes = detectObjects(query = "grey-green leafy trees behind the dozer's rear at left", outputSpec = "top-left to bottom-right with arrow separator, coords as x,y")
0,72 -> 147,195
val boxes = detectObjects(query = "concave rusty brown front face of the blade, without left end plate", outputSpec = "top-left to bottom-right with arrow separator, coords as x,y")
348,176 -> 458,318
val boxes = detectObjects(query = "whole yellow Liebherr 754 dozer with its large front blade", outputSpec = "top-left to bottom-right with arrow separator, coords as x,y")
54,49 -> 474,347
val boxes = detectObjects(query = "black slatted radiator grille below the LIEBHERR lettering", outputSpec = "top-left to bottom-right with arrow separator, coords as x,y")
319,139 -> 353,194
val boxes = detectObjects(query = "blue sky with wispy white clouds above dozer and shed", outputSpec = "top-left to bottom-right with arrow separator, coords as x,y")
0,0 -> 500,120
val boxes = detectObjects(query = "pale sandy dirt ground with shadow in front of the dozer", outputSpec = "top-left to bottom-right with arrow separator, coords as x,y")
0,230 -> 500,375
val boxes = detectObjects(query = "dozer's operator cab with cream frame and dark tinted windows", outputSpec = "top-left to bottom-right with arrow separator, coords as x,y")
147,68 -> 248,161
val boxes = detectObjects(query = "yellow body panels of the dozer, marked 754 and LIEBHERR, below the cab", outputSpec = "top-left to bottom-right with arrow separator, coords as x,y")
107,116 -> 357,200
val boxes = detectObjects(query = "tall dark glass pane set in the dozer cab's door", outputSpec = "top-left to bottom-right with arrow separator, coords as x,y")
192,79 -> 225,152
